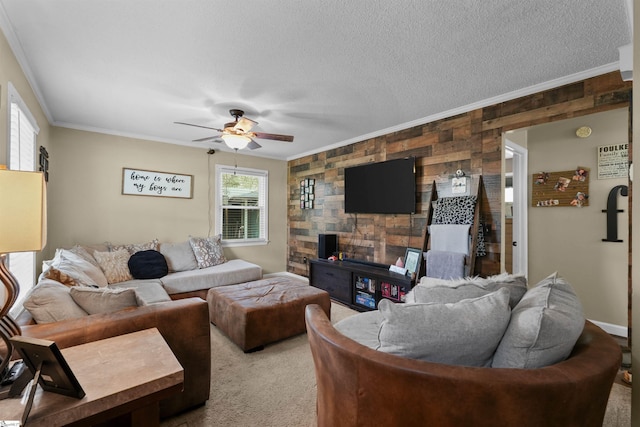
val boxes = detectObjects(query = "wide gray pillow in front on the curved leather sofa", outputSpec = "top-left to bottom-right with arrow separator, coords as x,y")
378,289 -> 510,366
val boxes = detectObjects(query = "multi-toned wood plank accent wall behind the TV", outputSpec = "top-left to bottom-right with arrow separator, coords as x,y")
287,72 -> 632,276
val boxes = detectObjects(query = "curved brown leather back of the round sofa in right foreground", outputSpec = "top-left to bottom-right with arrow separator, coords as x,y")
305,305 -> 622,427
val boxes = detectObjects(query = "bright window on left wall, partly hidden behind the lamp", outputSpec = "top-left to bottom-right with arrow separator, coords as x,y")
8,83 -> 40,316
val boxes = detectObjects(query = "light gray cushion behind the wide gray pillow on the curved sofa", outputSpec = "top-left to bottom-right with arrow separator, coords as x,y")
412,273 -> 527,309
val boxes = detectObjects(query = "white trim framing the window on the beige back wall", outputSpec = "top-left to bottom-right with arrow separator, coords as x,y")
215,165 -> 269,247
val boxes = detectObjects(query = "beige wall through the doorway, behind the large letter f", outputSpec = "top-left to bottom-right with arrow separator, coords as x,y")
528,109 -> 629,328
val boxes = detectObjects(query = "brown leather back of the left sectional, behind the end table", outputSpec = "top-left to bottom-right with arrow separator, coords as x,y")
21,298 -> 211,418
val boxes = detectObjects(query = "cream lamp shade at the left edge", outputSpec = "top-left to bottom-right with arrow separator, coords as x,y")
0,170 -> 47,254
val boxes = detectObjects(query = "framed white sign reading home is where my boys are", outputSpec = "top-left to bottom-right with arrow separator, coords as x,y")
122,168 -> 193,199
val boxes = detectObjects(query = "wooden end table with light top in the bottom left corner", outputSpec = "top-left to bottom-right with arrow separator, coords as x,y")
0,328 -> 184,427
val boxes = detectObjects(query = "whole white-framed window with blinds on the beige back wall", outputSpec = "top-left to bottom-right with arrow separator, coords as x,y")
216,165 -> 268,245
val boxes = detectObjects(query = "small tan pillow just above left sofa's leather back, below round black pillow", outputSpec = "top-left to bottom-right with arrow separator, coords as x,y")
69,287 -> 138,314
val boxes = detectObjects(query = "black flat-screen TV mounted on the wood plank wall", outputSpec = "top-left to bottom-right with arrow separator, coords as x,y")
344,157 -> 416,214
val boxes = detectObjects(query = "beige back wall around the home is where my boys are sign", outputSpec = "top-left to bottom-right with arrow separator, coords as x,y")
46,127 -> 288,273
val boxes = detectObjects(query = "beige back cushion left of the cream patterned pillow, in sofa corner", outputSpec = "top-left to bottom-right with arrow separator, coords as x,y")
43,249 -> 107,286
